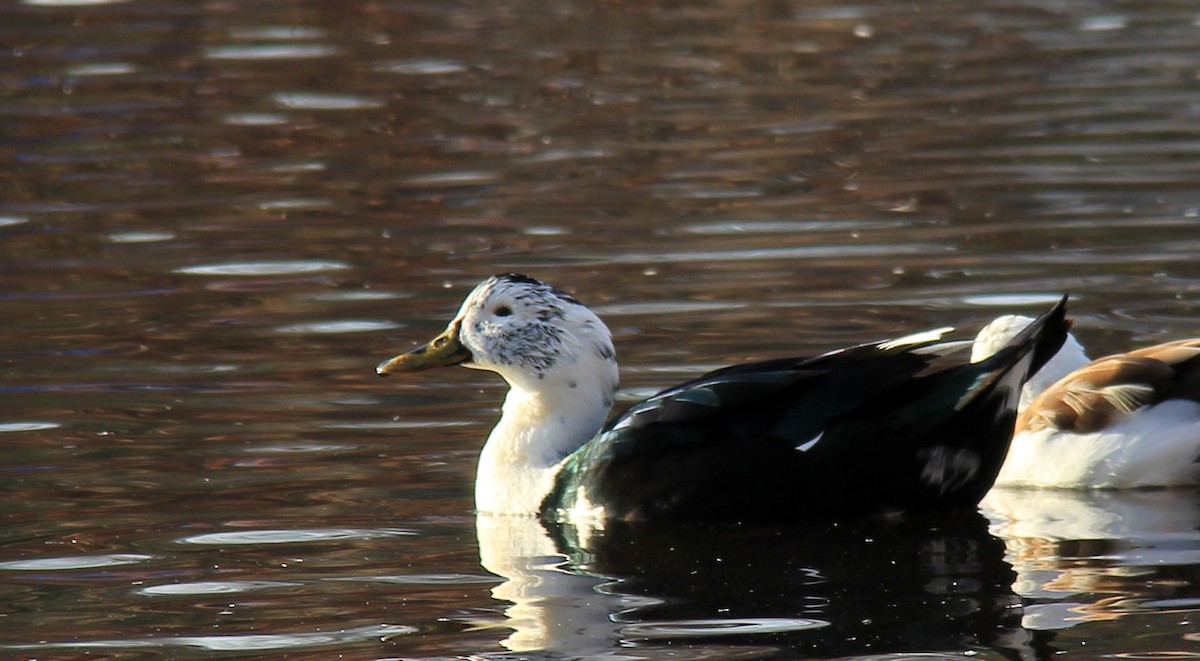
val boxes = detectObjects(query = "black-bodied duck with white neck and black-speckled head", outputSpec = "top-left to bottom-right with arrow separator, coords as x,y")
376,274 -> 1069,524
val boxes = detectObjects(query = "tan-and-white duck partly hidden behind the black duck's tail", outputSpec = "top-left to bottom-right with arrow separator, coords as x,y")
972,316 -> 1200,489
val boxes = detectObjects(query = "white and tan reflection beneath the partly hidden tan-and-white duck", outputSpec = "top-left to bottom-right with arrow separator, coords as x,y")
980,488 -> 1200,630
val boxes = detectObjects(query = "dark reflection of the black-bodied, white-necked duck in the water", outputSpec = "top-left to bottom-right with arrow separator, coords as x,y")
478,512 -> 1042,659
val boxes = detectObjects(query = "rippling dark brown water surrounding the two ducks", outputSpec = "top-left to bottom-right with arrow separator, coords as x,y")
0,0 -> 1200,661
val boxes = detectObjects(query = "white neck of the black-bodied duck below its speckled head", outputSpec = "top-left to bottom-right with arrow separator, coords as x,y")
475,368 -> 617,515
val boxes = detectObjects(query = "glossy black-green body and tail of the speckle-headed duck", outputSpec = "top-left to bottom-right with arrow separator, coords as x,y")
544,298 -> 1068,519
